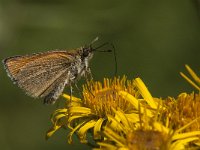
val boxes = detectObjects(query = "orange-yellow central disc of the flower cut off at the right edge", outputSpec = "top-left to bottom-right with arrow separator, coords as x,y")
162,93 -> 200,132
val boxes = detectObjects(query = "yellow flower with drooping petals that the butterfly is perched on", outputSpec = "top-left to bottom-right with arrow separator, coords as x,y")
47,76 -> 158,143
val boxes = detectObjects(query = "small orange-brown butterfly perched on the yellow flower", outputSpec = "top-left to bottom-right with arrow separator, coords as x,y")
3,37 -> 111,104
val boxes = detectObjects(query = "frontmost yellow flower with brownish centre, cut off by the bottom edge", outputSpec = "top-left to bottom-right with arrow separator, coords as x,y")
96,108 -> 200,150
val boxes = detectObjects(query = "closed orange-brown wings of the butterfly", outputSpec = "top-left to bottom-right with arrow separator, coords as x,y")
4,51 -> 74,103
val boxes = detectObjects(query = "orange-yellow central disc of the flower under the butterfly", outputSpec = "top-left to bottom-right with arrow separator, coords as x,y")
83,76 -> 140,117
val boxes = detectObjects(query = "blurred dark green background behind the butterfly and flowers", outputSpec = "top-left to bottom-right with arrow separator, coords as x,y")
0,0 -> 200,150
